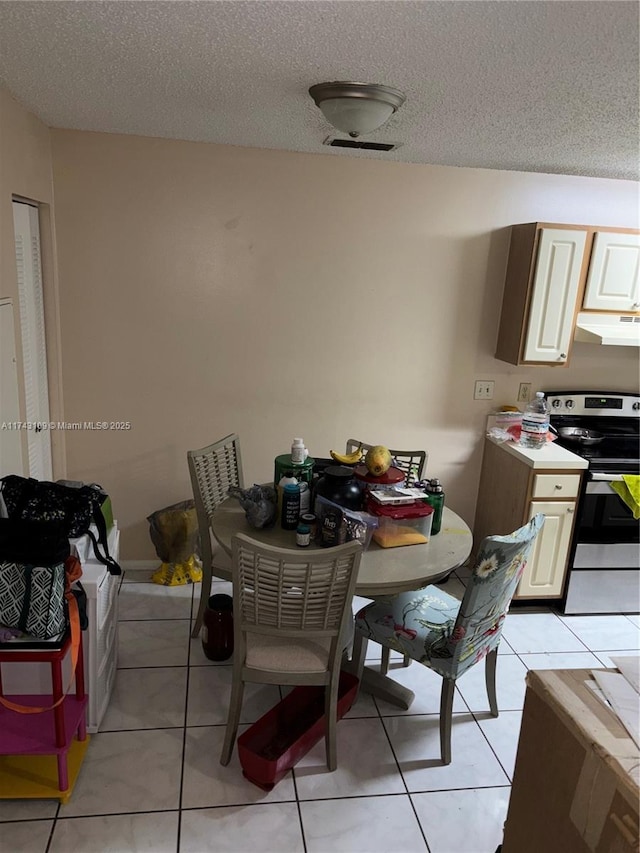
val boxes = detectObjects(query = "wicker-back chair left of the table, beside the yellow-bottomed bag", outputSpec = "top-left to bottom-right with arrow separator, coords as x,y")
187,433 -> 244,637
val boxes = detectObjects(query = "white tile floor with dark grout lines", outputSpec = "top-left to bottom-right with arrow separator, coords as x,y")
0,571 -> 640,853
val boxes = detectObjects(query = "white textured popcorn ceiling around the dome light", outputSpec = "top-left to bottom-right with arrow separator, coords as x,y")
0,0 -> 640,180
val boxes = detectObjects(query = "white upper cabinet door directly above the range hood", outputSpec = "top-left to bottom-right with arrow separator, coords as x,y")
582,231 -> 640,313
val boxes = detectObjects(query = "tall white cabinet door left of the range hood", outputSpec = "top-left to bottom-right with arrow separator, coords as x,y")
523,228 -> 587,364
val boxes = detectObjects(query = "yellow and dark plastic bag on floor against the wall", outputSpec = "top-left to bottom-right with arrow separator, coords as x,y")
147,500 -> 202,586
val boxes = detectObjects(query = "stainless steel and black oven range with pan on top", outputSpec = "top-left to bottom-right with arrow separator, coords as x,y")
546,391 -> 640,613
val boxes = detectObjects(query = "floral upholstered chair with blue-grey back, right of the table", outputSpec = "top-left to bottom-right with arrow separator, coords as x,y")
353,515 -> 544,764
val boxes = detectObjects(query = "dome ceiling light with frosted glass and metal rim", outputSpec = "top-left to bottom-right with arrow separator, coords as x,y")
309,82 -> 406,138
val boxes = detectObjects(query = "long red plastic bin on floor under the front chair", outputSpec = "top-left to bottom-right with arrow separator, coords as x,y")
238,670 -> 358,791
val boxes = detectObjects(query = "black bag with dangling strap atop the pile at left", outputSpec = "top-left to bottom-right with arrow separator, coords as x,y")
2,474 -> 122,575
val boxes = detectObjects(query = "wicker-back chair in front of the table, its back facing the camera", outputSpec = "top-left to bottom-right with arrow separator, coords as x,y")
220,534 -> 362,770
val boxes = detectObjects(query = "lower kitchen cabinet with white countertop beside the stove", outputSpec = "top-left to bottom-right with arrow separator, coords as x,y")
474,438 -> 586,600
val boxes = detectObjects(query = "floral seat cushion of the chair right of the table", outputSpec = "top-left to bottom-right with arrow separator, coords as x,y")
356,586 -> 460,664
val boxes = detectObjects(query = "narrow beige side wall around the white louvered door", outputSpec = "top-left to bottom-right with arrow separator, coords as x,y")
0,87 -> 65,477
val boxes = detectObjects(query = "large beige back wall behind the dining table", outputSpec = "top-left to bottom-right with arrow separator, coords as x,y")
52,131 -> 638,559
